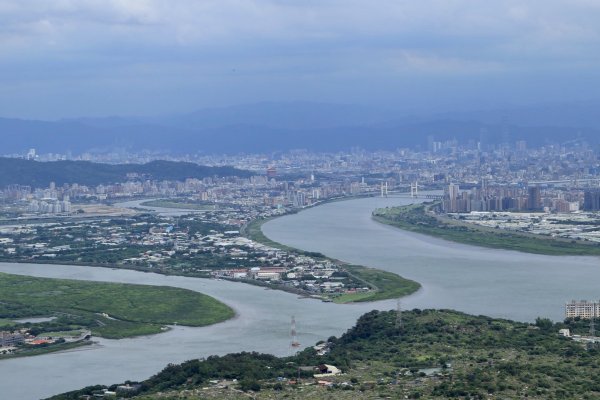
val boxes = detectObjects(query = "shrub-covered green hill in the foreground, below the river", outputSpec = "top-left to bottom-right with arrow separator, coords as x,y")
52,309 -> 600,400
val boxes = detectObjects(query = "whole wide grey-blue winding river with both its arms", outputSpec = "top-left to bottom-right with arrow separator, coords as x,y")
0,198 -> 600,399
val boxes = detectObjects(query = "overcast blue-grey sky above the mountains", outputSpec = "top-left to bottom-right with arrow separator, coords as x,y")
0,0 -> 600,119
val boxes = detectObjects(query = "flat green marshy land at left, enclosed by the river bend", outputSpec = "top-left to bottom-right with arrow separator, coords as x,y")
0,273 -> 234,338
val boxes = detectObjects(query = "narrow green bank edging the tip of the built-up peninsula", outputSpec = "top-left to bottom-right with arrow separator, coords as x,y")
242,218 -> 421,303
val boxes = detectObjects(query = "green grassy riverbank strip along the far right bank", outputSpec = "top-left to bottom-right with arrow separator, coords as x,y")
373,203 -> 600,256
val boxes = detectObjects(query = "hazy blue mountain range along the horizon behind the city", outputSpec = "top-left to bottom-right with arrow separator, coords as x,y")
0,101 -> 600,154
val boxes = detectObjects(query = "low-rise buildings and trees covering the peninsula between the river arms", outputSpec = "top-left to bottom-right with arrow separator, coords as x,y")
0,200 -> 369,294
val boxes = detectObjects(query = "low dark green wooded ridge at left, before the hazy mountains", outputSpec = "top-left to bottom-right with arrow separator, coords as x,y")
0,158 -> 251,188
